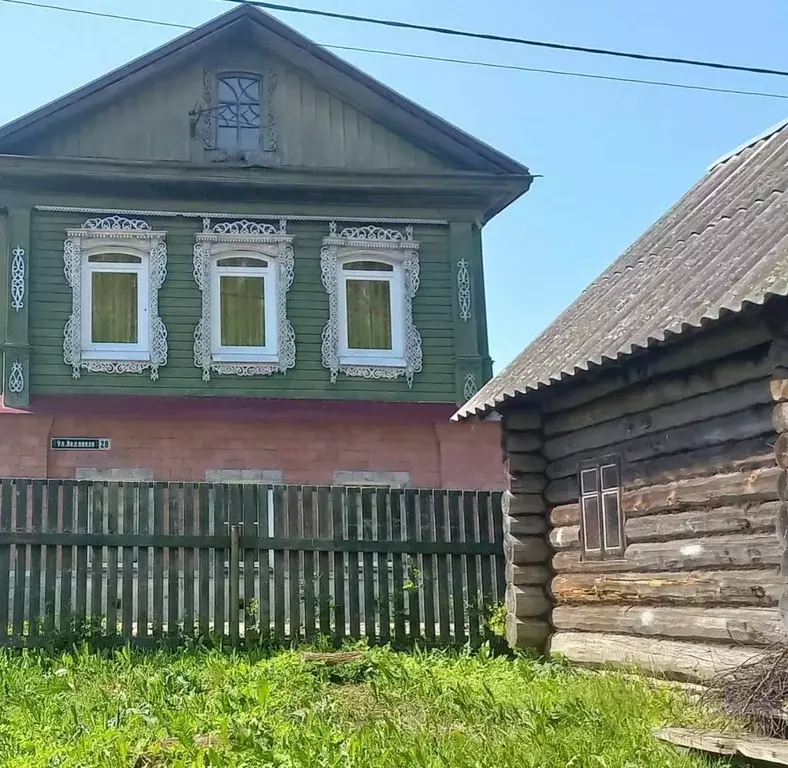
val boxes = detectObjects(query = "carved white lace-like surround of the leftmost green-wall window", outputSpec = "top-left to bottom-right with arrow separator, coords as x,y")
63,216 -> 168,381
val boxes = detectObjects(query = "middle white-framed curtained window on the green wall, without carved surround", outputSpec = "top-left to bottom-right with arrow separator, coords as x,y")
211,256 -> 276,360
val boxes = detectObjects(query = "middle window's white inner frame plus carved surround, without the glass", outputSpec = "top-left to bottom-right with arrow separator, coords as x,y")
194,219 -> 296,381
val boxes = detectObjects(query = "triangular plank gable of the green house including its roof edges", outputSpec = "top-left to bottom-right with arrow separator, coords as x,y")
0,6 -> 527,173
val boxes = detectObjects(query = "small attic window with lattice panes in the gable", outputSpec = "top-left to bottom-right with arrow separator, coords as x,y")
216,74 -> 260,152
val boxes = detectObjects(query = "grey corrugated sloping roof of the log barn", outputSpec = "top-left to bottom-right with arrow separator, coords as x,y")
454,117 -> 788,419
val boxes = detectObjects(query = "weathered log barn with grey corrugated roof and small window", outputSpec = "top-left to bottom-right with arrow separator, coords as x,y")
455,118 -> 788,679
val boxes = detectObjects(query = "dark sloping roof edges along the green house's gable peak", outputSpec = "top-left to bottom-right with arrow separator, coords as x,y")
0,5 -> 530,176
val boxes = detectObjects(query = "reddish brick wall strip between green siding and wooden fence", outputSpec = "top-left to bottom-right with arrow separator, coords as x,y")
0,414 -> 504,489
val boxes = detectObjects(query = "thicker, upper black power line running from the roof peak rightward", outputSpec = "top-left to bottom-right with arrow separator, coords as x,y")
234,0 -> 788,77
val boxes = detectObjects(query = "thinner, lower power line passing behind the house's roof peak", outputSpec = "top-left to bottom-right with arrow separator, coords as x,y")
0,0 -> 788,99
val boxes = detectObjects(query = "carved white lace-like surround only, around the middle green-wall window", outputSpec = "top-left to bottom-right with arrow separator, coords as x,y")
194,219 -> 296,381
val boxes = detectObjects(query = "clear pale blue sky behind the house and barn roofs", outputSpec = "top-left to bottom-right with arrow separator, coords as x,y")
0,0 -> 788,371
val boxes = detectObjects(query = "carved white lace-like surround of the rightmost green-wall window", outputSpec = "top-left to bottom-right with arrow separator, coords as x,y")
320,221 -> 422,387
